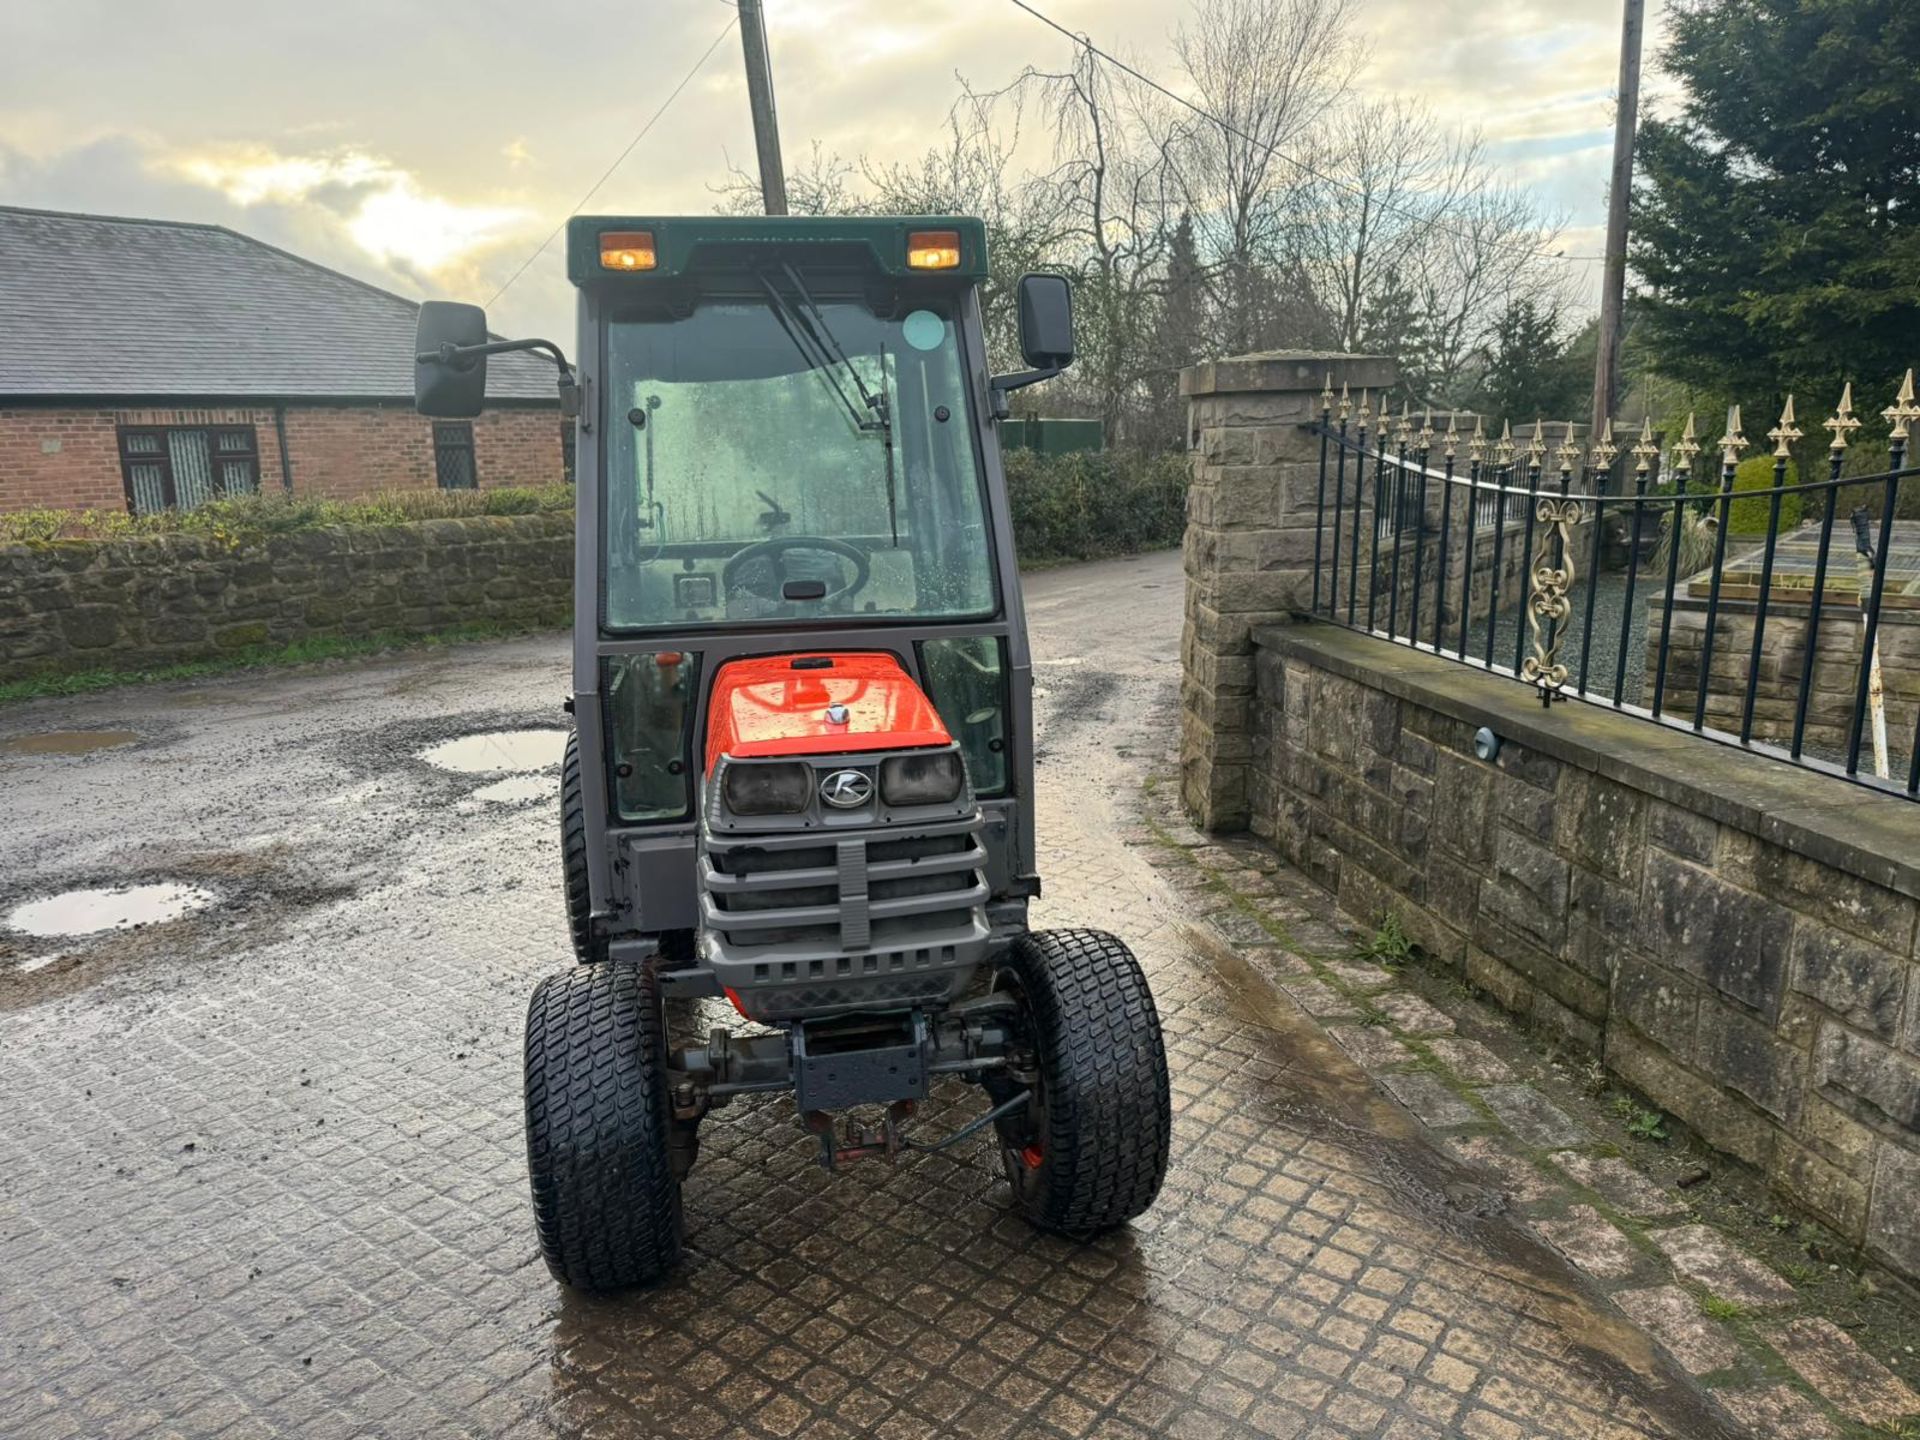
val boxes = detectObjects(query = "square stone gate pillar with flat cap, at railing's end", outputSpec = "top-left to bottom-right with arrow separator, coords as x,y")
1181,351 -> 1400,831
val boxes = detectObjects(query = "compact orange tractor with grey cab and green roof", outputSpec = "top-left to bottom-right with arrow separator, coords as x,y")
415,217 -> 1171,1290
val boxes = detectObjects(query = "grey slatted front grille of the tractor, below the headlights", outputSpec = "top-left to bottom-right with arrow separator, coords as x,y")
701,814 -> 987,960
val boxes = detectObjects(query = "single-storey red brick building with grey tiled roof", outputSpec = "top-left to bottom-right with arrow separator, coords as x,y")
0,205 -> 570,513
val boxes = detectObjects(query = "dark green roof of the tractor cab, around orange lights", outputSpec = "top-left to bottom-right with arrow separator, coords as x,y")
566,215 -> 987,288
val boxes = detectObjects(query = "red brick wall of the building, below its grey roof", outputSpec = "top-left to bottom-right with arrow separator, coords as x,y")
0,403 -> 563,513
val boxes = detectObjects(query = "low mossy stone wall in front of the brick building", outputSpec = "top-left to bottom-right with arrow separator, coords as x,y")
0,515 -> 574,682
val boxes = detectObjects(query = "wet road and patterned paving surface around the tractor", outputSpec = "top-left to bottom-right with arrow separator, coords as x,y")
0,557 -> 1740,1440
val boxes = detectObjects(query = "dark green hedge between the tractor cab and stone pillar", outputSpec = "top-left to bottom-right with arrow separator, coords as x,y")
1006,449 -> 1187,563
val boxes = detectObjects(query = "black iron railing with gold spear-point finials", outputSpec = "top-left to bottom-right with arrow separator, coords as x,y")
1309,372 -> 1920,799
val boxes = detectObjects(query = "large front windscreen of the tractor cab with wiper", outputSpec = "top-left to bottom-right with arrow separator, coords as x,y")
601,293 -> 995,630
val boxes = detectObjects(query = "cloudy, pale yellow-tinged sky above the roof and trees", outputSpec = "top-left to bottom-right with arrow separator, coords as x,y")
0,0 -> 1665,344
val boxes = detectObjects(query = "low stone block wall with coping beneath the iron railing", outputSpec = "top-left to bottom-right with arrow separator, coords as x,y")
1248,624 -> 1920,1277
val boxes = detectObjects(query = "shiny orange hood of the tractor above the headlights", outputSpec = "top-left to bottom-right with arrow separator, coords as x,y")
707,653 -> 952,774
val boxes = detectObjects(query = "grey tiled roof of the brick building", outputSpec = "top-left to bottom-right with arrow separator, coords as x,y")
0,205 -> 557,403
